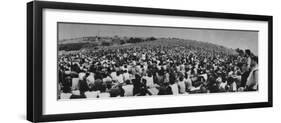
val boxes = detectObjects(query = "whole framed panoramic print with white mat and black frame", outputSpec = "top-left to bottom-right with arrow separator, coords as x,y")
26,1 -> 273,122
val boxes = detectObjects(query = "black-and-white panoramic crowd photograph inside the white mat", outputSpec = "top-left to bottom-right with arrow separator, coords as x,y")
57,22 -> 259,100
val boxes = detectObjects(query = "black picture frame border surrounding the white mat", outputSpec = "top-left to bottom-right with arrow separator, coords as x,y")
27,1 -> 273,122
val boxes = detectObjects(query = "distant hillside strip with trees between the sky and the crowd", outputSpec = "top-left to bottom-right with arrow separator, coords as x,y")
59,37 -> 236,54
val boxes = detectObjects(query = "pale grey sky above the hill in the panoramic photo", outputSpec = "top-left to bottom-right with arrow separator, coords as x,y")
58,23 -> 258,54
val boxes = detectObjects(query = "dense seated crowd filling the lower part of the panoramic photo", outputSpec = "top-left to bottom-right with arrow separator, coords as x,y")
58,45 -> 258,99
